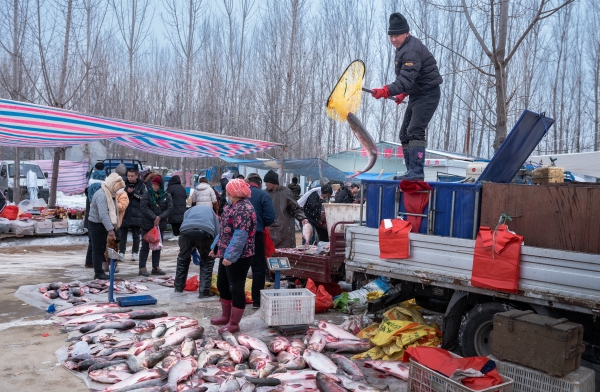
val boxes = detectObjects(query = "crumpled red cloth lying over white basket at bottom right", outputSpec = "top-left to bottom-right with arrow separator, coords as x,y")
402,346 -> 504,390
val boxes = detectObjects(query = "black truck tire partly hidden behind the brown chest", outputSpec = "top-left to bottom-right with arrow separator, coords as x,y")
458,302 -> 511,357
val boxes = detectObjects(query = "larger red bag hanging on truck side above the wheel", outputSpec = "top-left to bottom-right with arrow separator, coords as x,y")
471,225 -> 523,293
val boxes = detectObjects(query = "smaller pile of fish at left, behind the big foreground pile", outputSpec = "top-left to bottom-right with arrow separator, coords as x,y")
38,279 -> 148,305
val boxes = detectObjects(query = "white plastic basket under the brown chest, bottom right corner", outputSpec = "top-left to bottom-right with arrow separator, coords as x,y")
489,355 -> 596,392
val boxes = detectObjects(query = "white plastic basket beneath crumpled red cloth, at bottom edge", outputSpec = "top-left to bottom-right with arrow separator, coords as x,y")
408,359 -> 513,392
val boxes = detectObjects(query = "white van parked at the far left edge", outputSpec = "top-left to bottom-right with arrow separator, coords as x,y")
0,161 -> 50,203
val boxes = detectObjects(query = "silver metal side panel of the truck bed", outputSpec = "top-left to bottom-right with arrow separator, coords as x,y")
346,226 -> 600,315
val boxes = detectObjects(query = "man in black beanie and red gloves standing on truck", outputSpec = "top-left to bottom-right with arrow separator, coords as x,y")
372,12 -> 442,181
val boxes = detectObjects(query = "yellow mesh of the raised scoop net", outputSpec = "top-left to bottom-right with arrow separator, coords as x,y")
326,60 -> 365,121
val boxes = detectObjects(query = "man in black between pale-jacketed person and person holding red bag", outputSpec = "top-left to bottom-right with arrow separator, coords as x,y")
119,167 -> 147,261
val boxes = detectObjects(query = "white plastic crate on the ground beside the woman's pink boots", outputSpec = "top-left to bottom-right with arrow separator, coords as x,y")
260,289 -> 315,327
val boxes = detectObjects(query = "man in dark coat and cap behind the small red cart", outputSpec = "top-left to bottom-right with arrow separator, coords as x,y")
264,170 -> 309,249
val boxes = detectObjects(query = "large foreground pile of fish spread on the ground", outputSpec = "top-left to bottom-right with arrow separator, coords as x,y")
56,303 -> 408,392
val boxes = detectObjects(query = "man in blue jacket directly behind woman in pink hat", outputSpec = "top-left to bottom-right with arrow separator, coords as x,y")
248,173 -> 276,309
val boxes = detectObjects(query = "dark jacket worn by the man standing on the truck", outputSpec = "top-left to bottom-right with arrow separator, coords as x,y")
388,35 -> 442,95
